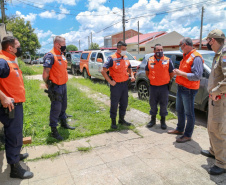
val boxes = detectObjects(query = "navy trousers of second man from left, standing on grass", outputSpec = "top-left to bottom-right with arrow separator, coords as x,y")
49,84 -> 67,127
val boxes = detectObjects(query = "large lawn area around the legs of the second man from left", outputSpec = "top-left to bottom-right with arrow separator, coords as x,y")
19,79 -> 134,146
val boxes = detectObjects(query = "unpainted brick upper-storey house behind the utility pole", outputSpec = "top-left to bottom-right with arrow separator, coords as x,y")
104,29 -> 142,48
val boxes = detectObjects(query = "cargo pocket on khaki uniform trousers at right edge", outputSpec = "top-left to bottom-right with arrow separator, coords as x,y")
213,100 -> 223,123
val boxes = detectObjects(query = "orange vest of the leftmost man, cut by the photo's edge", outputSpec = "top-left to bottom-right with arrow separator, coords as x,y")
0,50 -> 25,103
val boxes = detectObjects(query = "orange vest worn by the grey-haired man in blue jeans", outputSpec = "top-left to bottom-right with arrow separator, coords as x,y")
176,49 -> 204,89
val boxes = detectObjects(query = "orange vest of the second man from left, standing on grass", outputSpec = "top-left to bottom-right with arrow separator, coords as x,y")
49,48 -> 68,85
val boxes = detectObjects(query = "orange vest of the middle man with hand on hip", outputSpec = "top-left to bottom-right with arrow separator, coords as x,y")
109,53 -> 130,82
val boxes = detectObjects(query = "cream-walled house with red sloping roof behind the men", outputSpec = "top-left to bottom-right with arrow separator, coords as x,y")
126,31 -> 183,55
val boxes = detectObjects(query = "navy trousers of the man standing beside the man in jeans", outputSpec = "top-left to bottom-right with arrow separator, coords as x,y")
149,84 -> 169,116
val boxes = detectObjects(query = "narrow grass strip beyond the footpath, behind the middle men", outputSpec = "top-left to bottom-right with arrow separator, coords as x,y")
72,78 -> 176,120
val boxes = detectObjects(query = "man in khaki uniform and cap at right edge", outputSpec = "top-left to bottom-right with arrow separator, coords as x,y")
201,29 -> 226,175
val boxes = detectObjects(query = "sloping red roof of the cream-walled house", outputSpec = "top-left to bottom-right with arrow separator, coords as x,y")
126,31 -> 167,44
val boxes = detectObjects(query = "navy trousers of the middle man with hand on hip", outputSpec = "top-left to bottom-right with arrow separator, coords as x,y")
110,81 -> 128,118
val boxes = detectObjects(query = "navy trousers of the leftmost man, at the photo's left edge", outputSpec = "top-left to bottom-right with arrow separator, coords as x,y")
0,104 -> 23,164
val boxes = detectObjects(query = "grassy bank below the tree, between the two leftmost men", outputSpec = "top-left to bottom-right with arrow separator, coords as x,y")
18,59 -> 43,75
